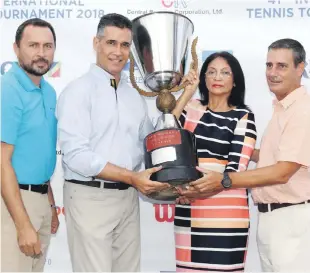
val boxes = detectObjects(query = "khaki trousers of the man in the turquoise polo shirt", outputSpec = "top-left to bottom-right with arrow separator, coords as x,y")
1,190 -> 52,272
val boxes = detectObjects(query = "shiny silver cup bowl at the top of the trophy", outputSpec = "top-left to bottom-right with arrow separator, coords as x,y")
131,11 -> 194,92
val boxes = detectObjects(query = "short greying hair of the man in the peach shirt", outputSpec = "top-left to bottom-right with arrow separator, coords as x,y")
268,38 -> 306,67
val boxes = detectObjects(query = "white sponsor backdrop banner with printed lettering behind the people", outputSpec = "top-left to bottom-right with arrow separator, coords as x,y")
0,0 -> 310,272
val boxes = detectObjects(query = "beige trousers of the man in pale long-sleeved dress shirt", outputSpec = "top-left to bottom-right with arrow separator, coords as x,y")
64,182 -> 140,272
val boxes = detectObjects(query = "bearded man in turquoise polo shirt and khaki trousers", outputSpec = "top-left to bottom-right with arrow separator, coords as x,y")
1,19 -> 59,271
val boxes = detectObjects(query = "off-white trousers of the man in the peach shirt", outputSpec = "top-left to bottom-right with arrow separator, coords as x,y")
257,204 -> 310,272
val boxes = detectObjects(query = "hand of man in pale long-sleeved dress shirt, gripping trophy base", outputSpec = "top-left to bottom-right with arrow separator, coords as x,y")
131,166 -> 171,195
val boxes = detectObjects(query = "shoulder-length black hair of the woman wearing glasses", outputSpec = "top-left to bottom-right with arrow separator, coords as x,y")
199,51 -> 247,108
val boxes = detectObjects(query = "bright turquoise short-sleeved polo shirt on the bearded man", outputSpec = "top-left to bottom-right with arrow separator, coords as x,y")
1,63 -> 57,185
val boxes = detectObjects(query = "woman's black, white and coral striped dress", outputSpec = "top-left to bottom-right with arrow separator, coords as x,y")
174,100 -> 256,272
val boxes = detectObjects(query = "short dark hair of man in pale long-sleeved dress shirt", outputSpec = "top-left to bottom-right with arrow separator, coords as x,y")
97,13 -> 132,35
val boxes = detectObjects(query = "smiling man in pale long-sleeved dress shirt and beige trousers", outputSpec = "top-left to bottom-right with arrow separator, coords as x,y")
57,14 -> 169,272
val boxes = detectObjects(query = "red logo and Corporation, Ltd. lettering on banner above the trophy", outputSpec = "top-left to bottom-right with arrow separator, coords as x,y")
158,0 -> 223,16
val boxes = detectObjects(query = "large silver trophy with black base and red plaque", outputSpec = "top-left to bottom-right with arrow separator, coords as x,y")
130,12 -> 201,201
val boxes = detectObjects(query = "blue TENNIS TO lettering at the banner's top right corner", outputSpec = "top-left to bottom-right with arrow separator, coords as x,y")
246,0 -> 310,19
